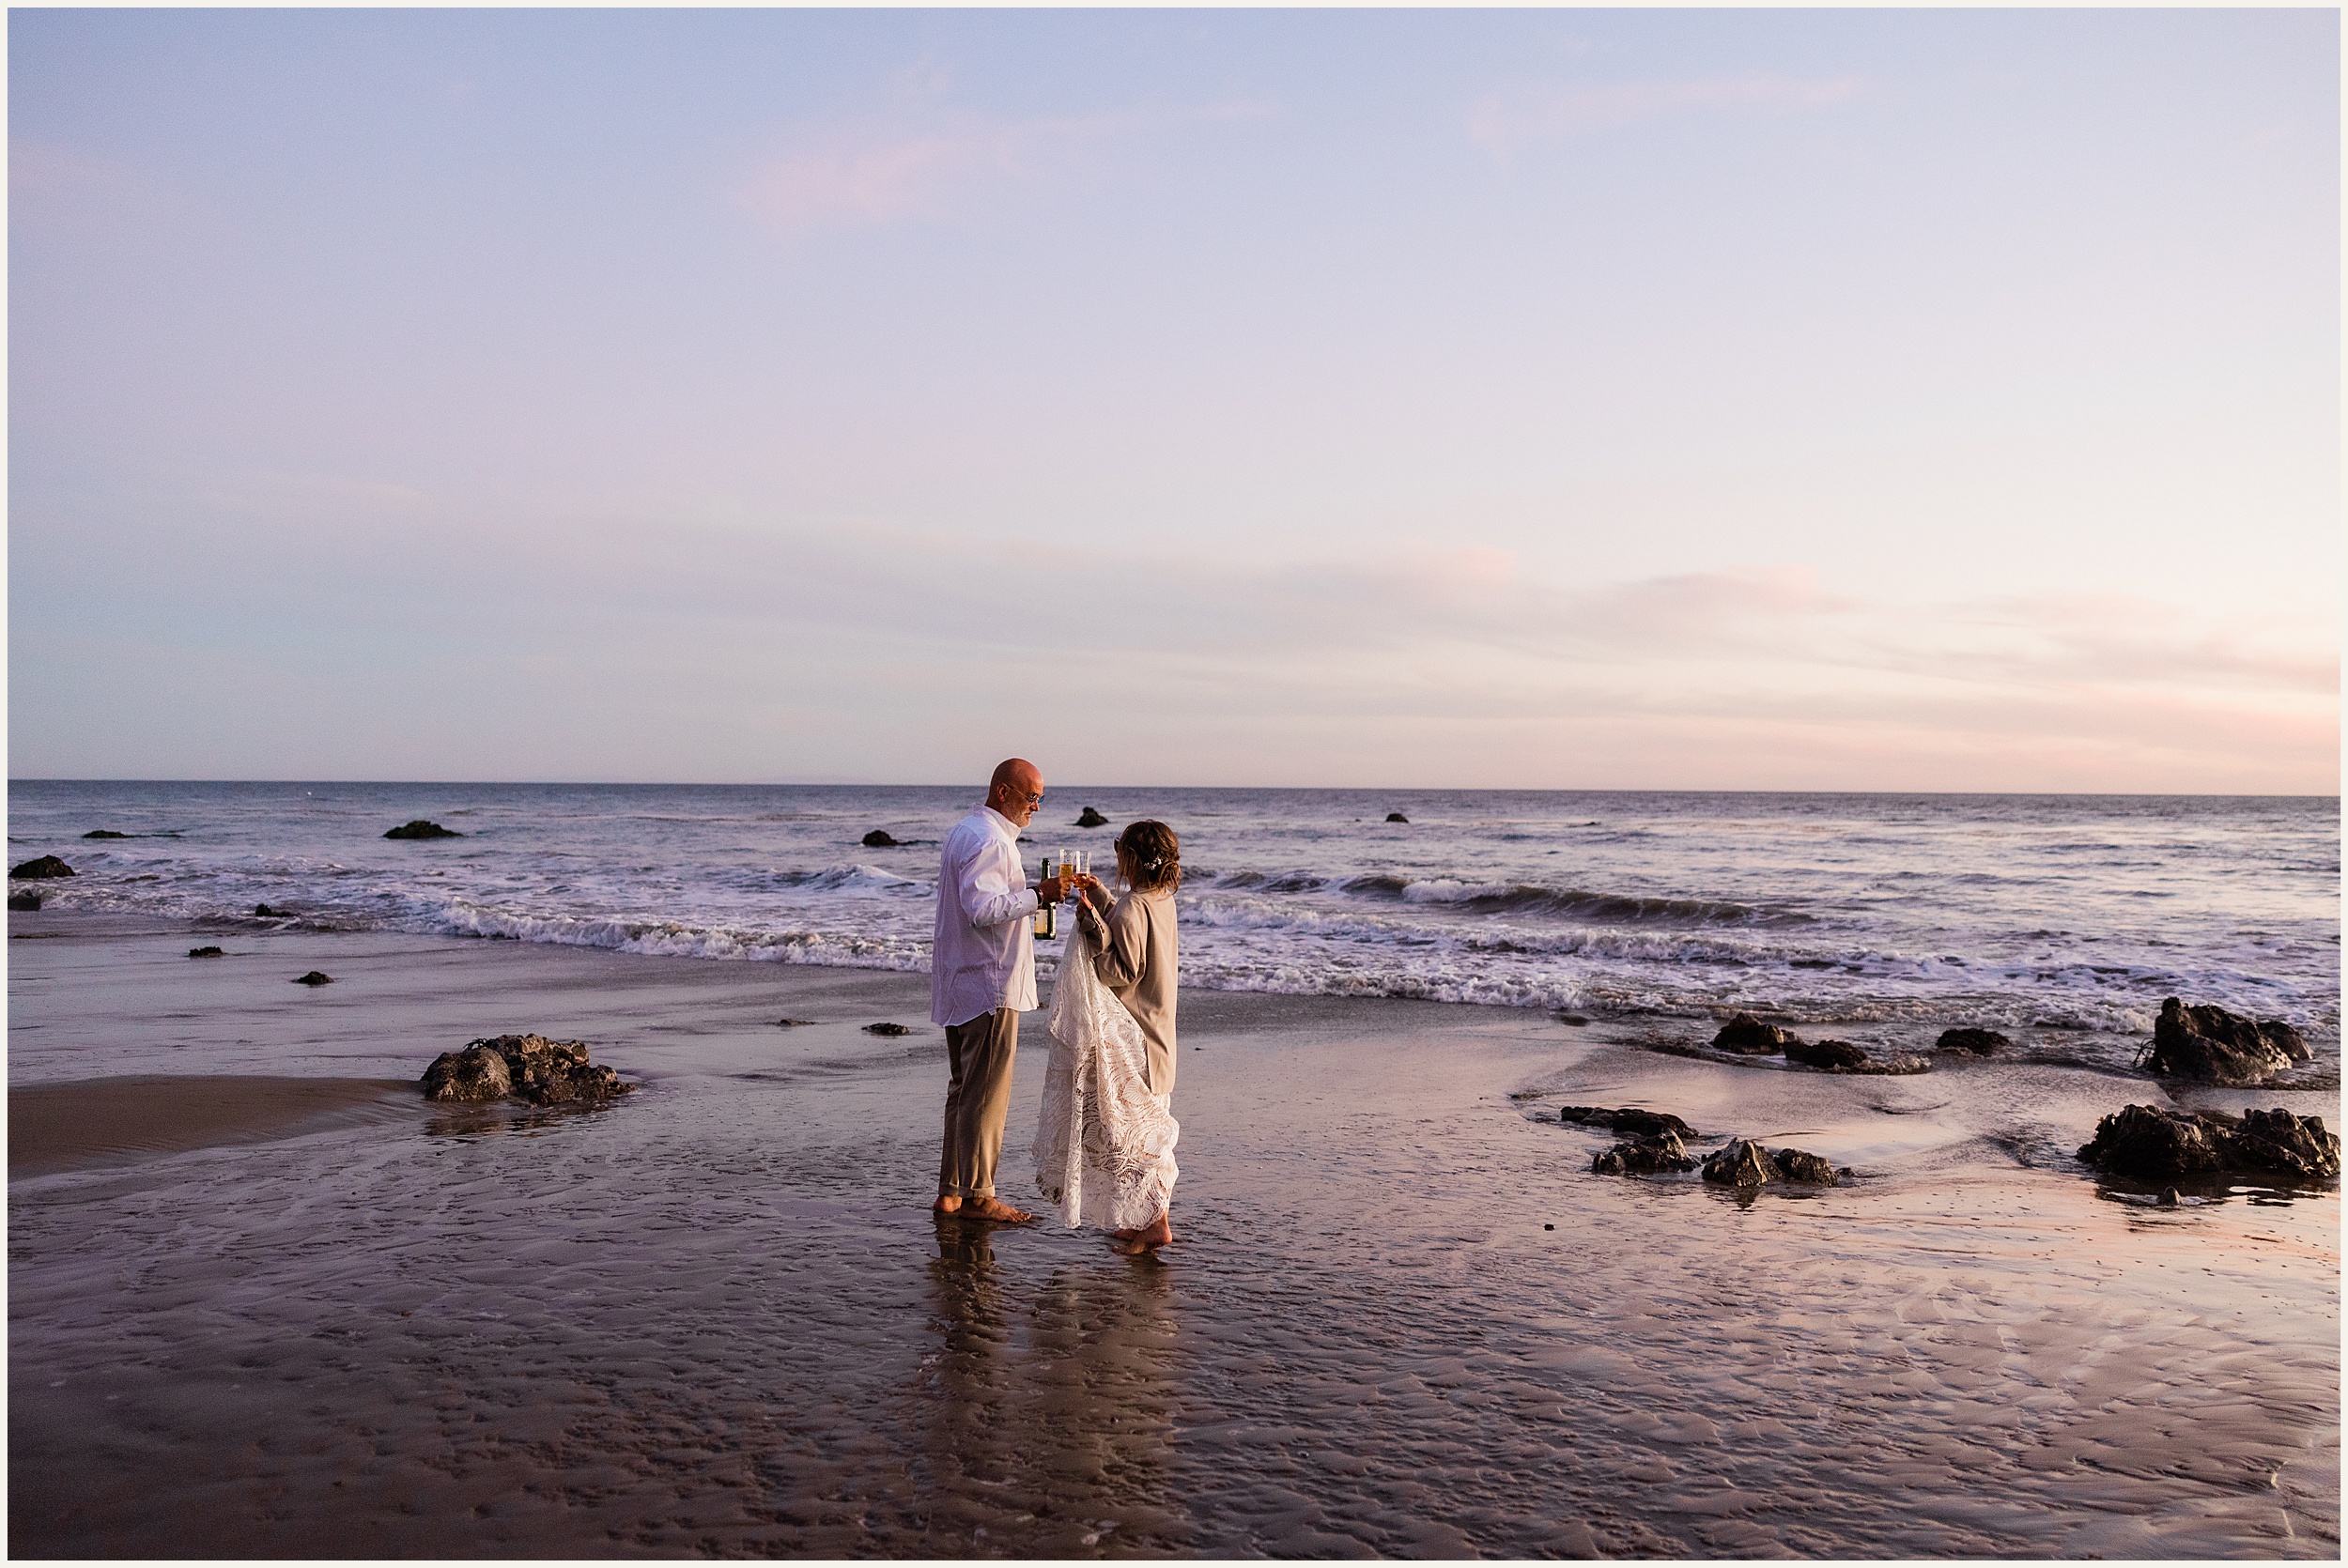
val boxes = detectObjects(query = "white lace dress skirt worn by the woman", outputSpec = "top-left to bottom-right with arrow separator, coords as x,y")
1036,920 -> 1182,1230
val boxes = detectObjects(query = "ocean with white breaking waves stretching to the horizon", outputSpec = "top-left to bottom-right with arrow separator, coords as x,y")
9,779 -> 2341,1054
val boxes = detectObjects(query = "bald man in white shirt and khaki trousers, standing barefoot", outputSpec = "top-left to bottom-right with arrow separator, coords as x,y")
930,756 -> 1069,1225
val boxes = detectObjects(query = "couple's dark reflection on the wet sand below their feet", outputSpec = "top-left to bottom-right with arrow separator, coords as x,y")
919,1216 -> 1179,1557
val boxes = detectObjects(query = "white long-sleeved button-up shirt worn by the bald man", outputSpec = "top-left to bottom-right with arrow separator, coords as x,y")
930,806 -> 1036,1026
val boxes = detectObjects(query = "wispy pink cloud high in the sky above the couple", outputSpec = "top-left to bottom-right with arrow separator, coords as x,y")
737,100 -> 1268,233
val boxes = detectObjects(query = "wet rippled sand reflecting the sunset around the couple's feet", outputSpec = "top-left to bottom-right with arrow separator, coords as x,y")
9,932 -> 2339,1557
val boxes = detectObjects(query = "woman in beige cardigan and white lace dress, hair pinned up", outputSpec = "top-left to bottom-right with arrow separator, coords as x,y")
1036,822 -> 1182,1253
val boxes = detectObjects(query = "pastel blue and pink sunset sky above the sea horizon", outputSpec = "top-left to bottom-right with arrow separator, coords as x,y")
9,9 -> 2341,793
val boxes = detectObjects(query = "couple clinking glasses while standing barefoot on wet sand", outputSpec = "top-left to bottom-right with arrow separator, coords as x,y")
930,759 -> 1182,1253
